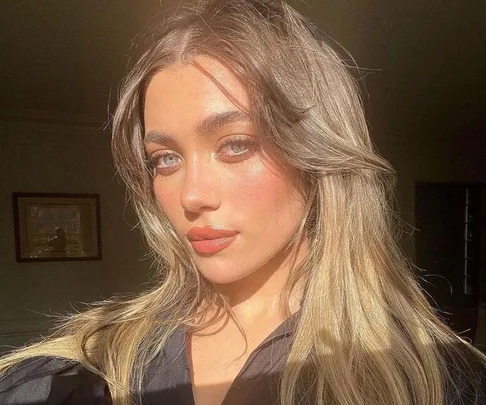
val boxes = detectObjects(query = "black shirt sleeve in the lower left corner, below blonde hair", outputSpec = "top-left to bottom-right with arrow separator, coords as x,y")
0,357 -> 107,405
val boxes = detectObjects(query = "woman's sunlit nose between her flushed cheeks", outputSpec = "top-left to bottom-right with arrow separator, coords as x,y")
181,157 -> 221,213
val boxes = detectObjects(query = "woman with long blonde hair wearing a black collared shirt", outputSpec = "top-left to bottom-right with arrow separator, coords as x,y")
0,0 -> 486,405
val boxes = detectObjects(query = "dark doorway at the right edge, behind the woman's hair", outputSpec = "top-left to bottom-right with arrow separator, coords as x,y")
415,183 -> 486,342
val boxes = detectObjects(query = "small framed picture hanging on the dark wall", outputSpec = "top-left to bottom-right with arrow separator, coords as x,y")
13,193 -> 101,262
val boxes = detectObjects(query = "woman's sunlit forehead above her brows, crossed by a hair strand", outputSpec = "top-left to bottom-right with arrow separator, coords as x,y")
144,56 -> 250,130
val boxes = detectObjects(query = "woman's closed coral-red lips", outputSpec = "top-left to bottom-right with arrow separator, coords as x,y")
186,226 -> 238,255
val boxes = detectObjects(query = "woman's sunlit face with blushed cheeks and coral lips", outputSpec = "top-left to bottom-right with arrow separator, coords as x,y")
144,56 -> 304,284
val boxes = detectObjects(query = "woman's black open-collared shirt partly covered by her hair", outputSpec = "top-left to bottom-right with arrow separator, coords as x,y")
0,316 -> 296,405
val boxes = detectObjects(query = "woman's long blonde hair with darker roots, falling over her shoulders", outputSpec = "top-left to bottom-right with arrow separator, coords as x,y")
0,0 -> 485,405
